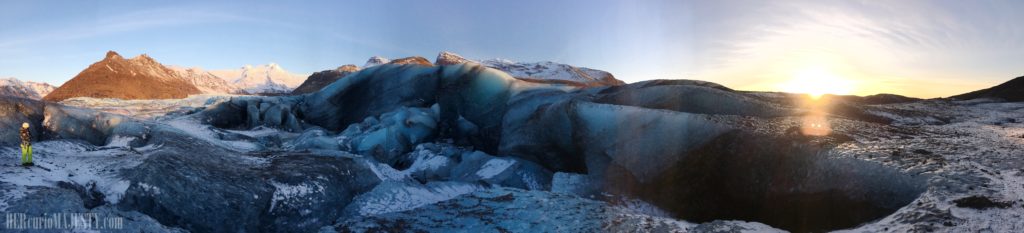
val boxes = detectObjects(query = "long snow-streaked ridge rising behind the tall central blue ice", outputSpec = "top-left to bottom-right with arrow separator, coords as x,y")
434,51 -> 626,86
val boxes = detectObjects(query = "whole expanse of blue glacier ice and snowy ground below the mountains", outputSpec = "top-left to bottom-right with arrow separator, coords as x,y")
0,64 -> 1024,232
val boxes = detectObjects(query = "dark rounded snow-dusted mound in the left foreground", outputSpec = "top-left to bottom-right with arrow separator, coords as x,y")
119,148 -> 379,232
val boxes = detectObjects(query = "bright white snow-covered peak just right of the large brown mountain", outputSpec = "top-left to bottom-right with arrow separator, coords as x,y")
210,63 -> 306,94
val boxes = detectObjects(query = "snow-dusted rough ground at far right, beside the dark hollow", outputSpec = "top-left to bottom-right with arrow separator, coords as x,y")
837,100 -> 1024,232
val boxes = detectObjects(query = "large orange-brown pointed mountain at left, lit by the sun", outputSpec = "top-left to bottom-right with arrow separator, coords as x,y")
43,51 -> 202,101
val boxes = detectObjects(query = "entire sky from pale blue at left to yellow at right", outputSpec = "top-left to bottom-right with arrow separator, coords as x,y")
0,0 -> 1024,98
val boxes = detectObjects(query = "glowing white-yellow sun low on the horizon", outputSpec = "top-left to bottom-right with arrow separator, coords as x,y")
778,67 -> 856,99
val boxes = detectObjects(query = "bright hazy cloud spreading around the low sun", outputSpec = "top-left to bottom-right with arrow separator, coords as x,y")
701,1 -> 1024,97
